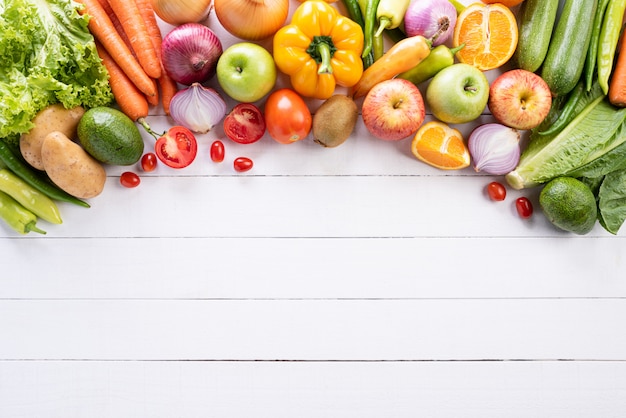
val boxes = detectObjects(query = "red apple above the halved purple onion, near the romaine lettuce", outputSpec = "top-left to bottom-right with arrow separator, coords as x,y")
487,69 -> 552,130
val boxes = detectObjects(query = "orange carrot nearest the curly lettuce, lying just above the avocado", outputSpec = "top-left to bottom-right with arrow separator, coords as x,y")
96,41 -> 148,121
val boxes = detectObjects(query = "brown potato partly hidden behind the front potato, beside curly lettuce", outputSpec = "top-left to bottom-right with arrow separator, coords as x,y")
20,103 -> 85,170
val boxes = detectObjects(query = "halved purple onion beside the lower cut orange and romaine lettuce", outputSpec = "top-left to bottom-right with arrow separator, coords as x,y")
467,123 -> 520,175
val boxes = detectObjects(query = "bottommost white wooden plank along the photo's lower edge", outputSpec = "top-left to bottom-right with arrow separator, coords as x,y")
0,361 -> 626,418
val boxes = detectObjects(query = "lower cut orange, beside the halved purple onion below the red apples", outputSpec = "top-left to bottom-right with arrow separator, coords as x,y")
411,120 -> 470,170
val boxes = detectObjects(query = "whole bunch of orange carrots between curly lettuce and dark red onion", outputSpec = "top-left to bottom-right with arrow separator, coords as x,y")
78,0 -> 178,121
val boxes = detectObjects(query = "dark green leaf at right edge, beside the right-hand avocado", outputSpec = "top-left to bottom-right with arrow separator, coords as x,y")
598,170 -> 626,235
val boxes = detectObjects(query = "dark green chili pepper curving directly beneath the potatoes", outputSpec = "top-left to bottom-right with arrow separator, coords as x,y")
0,139 -> 90,208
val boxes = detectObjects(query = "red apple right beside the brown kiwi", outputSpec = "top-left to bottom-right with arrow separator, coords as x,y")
361,78 -> 426,141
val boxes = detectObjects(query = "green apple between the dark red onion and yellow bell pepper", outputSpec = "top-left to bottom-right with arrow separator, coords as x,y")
216,42 -> 277,103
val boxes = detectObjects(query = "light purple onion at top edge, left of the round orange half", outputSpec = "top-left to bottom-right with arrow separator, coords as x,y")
404,0 -> 456,46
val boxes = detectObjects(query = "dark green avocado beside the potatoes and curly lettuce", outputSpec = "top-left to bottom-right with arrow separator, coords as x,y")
78,106 -> 144,165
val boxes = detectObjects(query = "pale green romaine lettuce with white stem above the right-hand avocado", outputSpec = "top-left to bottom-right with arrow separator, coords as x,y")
506,96 -> 626,189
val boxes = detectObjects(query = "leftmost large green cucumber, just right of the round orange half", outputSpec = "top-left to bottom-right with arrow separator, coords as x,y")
514,0 -> 559,73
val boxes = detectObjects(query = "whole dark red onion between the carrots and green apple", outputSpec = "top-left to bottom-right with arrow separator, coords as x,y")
161,23 -> 222,86
